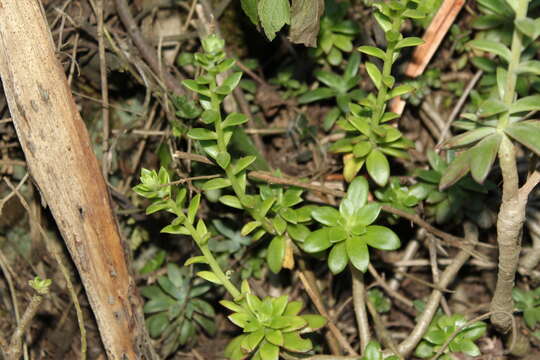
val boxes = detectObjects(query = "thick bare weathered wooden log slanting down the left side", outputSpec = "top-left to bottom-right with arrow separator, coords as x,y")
0,0 -> 156,359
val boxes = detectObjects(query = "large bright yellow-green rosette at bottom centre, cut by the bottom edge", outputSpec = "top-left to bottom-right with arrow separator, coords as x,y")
221,282 -> 326,360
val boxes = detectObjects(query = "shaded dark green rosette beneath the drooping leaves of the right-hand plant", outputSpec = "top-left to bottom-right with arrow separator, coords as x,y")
409,150 -> 495,229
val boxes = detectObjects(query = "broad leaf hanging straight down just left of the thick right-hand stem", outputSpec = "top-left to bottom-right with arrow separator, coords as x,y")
469,134 -> 502,184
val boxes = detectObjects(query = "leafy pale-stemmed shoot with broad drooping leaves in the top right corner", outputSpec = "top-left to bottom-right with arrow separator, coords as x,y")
440,0 -> 540,189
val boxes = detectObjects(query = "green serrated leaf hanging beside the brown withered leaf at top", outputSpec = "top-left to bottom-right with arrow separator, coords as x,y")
257,0 -> 291,40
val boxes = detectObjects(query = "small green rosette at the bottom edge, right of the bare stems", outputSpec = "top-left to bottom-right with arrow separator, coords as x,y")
415,314 -> 487,360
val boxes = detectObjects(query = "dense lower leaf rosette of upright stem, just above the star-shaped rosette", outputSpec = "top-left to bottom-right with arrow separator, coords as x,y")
329,102 -> 412,186
